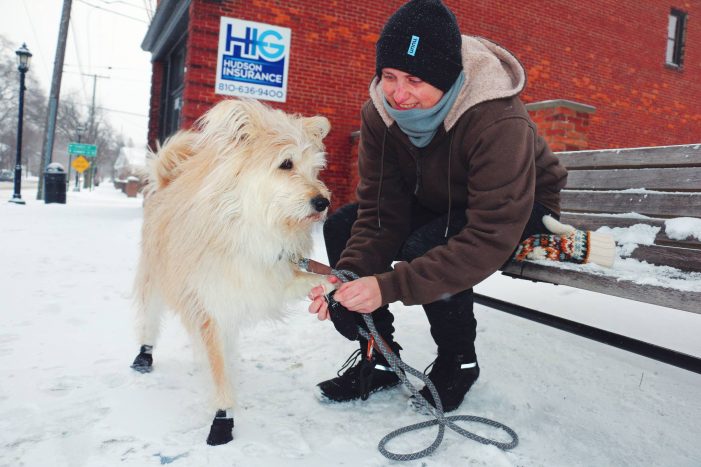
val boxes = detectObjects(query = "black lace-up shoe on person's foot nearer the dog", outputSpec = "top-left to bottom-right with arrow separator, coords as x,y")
317,344 -> 401,402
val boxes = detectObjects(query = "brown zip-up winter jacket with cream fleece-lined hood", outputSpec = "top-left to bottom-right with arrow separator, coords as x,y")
337,36 -> 567,305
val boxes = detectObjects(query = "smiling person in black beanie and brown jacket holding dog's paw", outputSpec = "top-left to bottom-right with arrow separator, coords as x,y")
309,0 -> 567,411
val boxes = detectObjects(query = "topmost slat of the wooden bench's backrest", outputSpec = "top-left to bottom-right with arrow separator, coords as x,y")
557,144 -> 701,169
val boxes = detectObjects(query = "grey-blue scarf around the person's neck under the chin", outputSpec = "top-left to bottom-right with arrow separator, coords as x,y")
382,72 -> 465,148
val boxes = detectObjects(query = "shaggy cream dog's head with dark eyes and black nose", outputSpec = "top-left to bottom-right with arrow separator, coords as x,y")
193,100 -> 330,230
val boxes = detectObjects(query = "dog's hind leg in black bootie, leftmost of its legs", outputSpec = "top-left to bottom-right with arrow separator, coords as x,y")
131,284 -> 164,373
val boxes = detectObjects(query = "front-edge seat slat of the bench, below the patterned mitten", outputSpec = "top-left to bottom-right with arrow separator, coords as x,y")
502,261 -> 701,314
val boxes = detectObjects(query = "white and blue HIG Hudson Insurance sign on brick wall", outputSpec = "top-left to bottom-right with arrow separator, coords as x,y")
215,17 -> 291,102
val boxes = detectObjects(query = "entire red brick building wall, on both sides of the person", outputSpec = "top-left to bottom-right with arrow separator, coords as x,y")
145,0 -> 701,206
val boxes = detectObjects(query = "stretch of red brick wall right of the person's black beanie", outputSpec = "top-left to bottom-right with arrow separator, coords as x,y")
447,0 -> 701,149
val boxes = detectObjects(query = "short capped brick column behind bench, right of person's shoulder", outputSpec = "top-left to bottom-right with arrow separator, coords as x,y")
526,99 -> 596,151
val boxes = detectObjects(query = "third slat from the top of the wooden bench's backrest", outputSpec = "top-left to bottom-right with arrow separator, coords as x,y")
560,189 -> 701,218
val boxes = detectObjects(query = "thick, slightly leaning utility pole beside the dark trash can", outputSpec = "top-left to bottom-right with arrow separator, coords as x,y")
37,0 -> 72,199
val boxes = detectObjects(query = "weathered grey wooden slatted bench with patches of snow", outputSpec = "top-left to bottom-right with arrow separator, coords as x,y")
502,144 -> 701,313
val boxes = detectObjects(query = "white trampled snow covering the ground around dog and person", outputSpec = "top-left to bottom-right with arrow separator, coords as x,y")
0,184 -> 701,467
